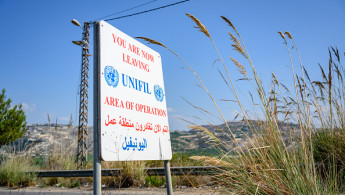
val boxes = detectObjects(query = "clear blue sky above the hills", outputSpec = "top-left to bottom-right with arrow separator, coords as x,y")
0,0 -> 345,130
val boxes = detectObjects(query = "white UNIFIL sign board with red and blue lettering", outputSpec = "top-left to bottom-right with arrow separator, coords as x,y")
98,21 -> 172,161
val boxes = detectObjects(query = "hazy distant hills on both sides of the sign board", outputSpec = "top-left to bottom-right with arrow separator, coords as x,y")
0,121 -> 298,157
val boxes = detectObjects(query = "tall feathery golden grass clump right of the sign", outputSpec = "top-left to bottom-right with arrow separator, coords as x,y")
138,14 -> 345,194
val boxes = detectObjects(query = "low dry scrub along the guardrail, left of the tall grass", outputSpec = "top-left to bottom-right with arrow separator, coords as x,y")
0,140 -> 210,188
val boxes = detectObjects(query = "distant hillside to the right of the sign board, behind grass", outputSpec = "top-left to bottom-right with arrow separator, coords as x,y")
170,120 -> 298,155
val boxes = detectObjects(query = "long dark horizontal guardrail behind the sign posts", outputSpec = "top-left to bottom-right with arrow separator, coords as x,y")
28,166 -> 222,177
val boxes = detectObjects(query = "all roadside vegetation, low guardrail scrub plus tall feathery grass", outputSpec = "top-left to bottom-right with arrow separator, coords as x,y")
0,14 -> 345,194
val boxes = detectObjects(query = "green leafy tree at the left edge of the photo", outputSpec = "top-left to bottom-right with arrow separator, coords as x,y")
0,89 -> 26,147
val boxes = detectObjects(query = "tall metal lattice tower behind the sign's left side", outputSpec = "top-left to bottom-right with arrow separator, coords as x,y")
77,22 -> 91,169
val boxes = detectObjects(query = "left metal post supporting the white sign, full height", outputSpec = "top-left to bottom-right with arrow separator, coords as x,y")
93,22 -> 102,195
